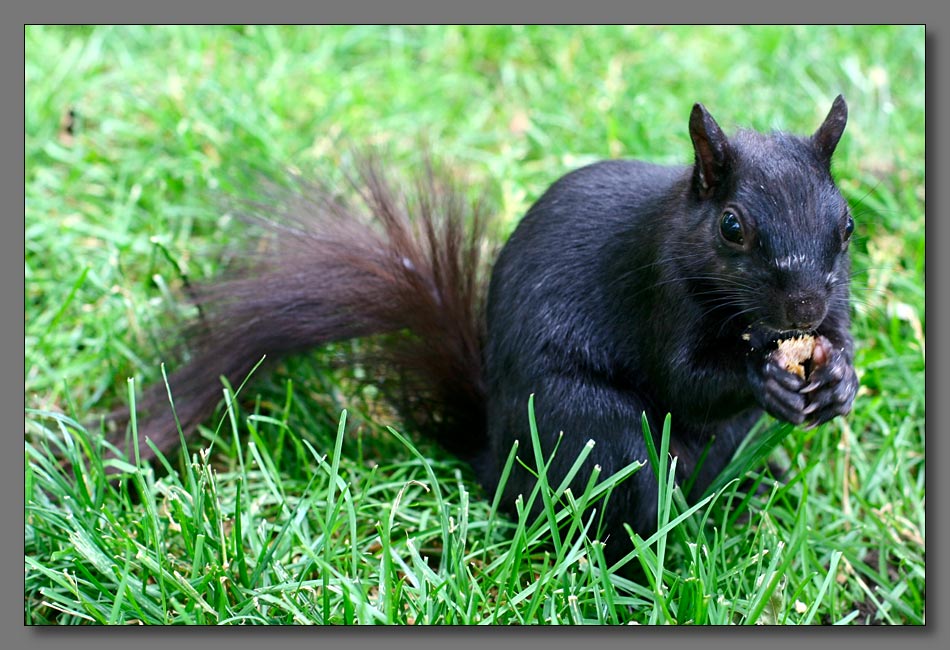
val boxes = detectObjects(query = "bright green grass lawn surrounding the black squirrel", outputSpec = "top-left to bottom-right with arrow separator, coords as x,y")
24,26 -> 926,624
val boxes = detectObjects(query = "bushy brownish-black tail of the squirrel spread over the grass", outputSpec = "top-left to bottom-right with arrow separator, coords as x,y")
109,158 -> 491,464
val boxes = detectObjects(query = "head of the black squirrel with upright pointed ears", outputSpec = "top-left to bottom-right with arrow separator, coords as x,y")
687,95 -> 854,331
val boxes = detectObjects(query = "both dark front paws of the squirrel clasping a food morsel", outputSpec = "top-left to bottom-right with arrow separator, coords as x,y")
748,335 -> 858,428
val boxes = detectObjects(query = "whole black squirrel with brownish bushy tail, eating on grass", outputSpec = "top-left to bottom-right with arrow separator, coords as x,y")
108,96 -> 858,557
